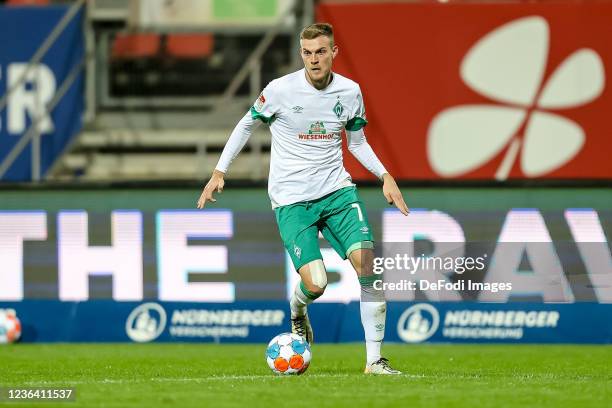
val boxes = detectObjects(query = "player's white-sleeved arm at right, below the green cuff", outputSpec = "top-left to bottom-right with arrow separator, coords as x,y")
346,128 -> 410,215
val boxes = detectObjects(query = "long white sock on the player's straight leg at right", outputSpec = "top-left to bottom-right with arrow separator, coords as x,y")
359,277 -> 387,365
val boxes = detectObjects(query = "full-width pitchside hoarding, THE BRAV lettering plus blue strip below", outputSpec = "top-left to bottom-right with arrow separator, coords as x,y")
0,186 -> 612,343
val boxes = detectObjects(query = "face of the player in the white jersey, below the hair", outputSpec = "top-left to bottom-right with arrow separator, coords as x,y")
300,35 -> 338,86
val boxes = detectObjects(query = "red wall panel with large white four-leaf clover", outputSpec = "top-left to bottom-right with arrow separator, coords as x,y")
317,0 -> 612,180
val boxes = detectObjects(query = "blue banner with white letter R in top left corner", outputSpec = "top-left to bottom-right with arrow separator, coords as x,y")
0,5 -> 85,182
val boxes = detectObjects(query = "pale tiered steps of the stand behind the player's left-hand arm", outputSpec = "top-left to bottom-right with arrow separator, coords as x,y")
51,128 -> 270,181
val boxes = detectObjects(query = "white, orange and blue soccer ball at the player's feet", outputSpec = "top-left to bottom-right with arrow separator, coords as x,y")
266,333 -> 312,375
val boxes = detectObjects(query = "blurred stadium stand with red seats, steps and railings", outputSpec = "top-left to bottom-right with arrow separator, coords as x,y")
48,0 -> 314,181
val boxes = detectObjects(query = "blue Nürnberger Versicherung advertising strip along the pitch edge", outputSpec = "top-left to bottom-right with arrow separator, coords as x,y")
0,300 -> 612,344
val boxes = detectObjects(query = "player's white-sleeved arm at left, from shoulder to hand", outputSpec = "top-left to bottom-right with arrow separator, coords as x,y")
197,84 -> 275,209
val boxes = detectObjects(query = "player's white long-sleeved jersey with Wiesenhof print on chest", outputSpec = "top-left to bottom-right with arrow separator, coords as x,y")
217,69 -> 385,207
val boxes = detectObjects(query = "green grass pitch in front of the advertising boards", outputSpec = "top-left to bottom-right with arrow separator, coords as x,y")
0,344 -> 612,408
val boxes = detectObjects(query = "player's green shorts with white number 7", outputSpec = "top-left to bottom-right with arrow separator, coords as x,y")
274,186 -> 374,271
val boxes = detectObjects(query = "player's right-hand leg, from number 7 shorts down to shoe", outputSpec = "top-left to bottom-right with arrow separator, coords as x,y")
322,188 -> 400,374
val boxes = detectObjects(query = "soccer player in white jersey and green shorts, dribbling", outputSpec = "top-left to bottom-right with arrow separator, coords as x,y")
197,23 -> 409,374
